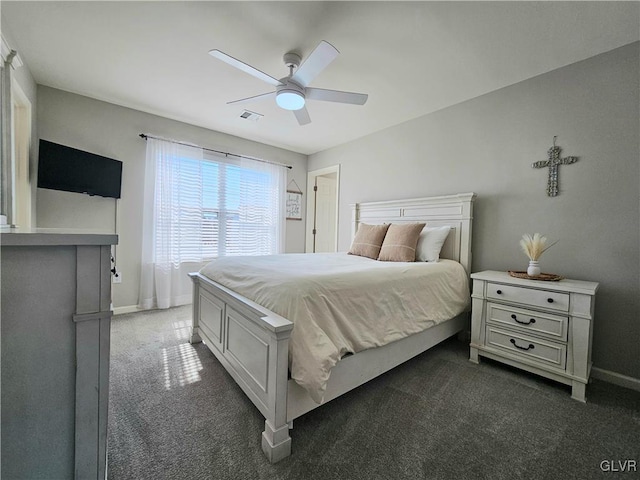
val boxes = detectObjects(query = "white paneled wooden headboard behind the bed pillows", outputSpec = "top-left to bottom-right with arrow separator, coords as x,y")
351,193 -> 476,274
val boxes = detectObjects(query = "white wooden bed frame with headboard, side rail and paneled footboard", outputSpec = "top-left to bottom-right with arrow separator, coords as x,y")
190,193 -> 475,463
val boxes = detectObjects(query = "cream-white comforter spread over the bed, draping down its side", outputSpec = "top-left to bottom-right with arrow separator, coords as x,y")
200,253 -> 469,403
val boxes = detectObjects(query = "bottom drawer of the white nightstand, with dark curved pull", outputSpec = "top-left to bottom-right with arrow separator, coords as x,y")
486,325 -> 567,370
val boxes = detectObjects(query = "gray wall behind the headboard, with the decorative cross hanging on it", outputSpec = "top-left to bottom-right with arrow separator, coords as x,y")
309,43 -> 640,378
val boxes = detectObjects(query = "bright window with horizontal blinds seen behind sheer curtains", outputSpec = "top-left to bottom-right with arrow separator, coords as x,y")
162,156 -> 282,264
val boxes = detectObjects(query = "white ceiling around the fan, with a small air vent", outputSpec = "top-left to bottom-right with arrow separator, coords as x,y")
1,0 -> 640,154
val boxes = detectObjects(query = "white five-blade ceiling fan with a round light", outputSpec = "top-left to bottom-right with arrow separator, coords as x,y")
209,40 -> 368,125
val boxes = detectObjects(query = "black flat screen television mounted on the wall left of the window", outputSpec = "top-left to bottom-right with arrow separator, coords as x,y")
38,140 -> 122,198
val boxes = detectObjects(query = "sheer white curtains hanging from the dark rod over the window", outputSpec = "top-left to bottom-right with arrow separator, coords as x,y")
139,138 -> 286,309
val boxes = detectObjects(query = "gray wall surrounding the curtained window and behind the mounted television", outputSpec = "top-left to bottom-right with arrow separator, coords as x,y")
37,86 -> 307,308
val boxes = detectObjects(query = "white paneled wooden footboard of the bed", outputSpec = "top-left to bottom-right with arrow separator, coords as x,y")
189,273 -> 293,463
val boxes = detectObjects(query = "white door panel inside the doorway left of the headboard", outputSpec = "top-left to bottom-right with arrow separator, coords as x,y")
314,174 -> 337,252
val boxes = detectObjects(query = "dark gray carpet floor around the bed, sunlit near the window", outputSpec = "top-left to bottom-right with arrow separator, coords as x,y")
108,307 -> 640,480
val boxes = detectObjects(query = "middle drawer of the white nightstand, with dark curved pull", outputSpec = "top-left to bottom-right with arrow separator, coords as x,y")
487,303 -> 569,342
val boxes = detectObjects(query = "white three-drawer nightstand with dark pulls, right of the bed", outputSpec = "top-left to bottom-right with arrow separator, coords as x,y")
469,271 -> 598,402
